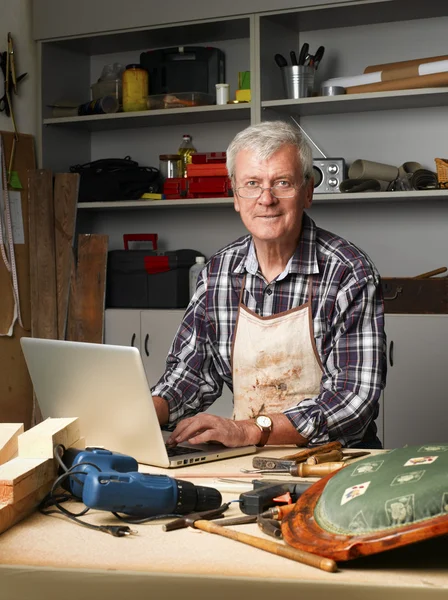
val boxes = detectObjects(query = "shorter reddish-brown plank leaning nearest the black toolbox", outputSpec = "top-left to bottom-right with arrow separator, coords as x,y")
67,234 -> 109,344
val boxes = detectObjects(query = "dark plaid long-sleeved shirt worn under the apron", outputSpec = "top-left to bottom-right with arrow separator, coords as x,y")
152,214 -> 386,447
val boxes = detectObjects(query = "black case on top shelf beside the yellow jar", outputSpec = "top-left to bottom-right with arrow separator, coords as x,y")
140,46 -> 225,96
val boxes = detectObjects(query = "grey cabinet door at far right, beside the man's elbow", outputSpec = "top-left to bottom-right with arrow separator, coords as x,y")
384,315 -> 448,448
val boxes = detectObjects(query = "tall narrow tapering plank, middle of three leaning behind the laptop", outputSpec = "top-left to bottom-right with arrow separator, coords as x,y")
54,173 -> 79,340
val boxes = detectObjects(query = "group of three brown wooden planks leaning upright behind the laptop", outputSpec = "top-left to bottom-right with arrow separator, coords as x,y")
28,169 -> 108,343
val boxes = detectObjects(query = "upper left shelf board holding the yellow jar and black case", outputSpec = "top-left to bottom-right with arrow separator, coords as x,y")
43,103 -> 250,131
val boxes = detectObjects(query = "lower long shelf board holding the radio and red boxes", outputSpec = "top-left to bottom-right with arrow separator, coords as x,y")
78,190 -> 448,211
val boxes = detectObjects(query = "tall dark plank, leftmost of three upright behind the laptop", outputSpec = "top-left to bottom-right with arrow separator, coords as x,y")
28,169 -> 58,339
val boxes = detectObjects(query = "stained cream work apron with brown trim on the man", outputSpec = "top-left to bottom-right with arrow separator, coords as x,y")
232,276 -> 323,420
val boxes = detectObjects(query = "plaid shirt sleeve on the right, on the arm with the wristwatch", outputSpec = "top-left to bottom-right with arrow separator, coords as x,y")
284,274 -> 386,446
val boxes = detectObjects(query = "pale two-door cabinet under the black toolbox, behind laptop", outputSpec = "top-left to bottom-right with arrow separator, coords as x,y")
104,308 -> 233,417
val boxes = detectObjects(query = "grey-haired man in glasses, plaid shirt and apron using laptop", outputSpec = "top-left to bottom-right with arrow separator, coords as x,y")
153,122 -> 386,448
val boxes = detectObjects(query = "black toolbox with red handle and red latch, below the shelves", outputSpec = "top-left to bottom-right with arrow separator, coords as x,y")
106,234 -> 204,308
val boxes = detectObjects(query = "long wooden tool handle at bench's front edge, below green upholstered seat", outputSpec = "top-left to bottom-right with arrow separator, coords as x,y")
194,519 -> 337,573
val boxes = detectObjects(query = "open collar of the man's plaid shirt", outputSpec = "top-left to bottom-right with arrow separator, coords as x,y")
234,213 -> 319,280
